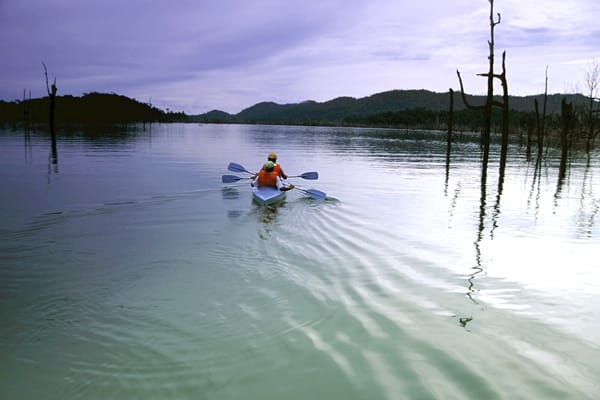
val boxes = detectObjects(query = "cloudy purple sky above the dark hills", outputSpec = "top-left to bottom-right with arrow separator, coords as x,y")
0,0 -> 600,114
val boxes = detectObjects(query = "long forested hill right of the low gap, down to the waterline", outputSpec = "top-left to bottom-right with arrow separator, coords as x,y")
190,90 -> 586,127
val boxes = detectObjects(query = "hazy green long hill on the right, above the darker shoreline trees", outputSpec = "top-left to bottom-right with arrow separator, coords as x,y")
190,90 -> 585,125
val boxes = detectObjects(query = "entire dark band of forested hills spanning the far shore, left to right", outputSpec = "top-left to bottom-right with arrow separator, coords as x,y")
0,90 -> 587,129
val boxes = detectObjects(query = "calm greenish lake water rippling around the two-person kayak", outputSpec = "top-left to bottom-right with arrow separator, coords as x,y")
0,125 -> 600,400
